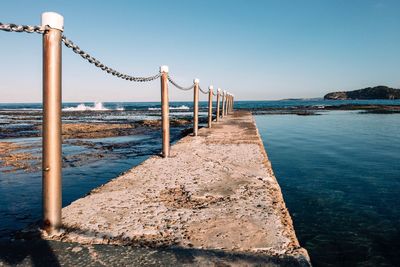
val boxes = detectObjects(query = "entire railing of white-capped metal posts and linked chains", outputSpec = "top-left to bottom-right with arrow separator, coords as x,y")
0,12 -> 233,233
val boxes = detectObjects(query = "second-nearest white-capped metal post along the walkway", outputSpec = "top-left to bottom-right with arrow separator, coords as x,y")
160,66 -> 169,158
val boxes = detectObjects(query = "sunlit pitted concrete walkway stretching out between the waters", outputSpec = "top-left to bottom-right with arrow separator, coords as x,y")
47,111 -> 310,266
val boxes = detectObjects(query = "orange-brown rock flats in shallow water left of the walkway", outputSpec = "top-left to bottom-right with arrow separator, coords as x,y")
0,119 -> 195,173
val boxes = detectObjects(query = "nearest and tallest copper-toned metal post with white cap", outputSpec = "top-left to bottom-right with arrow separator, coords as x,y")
42,12 -> 64,233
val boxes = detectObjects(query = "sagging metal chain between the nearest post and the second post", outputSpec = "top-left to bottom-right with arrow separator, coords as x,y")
62,35 -> 161,82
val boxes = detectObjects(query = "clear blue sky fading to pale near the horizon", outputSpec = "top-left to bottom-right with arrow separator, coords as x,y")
0,0 -> 400,102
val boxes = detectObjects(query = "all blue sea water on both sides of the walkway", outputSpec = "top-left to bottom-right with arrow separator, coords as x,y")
0,100 -> 400,266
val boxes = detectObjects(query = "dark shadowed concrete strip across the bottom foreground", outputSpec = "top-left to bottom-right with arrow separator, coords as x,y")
0,225 -> 310,267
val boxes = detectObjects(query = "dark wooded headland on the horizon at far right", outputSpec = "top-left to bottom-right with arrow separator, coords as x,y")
324,85 -> 400,100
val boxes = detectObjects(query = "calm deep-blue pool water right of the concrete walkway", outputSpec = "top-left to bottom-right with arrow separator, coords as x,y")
256,111 -> 400,266
